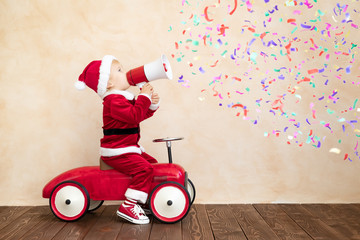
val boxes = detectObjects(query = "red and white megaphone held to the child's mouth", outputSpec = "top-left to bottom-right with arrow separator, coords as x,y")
126,54 -> 172,88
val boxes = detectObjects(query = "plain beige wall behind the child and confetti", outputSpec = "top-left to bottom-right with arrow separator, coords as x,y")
0,0 -> 360,205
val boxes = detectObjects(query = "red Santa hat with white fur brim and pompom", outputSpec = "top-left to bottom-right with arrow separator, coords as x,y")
75,55 -> 116,98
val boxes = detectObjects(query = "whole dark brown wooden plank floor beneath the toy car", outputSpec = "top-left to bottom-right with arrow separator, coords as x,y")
0,204 -> 360,240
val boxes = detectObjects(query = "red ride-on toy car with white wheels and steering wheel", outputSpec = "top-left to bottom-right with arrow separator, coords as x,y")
43,138 -> 195,223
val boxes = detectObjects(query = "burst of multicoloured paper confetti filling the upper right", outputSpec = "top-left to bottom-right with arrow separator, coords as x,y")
168,0 -> 360,162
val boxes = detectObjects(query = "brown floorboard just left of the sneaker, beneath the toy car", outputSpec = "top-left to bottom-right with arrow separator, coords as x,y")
84,205 -> 123,240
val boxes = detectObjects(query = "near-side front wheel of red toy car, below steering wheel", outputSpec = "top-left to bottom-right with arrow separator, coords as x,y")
150,182 -> 191,223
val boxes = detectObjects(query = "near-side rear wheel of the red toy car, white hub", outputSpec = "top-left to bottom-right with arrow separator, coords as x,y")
49,181 -> 90,221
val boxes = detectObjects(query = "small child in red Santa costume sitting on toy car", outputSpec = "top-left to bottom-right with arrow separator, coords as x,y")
77,55 -> 159,224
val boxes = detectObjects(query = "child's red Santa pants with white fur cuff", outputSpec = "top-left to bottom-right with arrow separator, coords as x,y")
101,153 -> 157,203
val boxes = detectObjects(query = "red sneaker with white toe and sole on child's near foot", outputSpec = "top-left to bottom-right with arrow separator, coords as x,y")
116,204 -> 150,224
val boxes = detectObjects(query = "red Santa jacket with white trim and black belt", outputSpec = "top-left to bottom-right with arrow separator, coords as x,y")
100,90 -> 158,157
